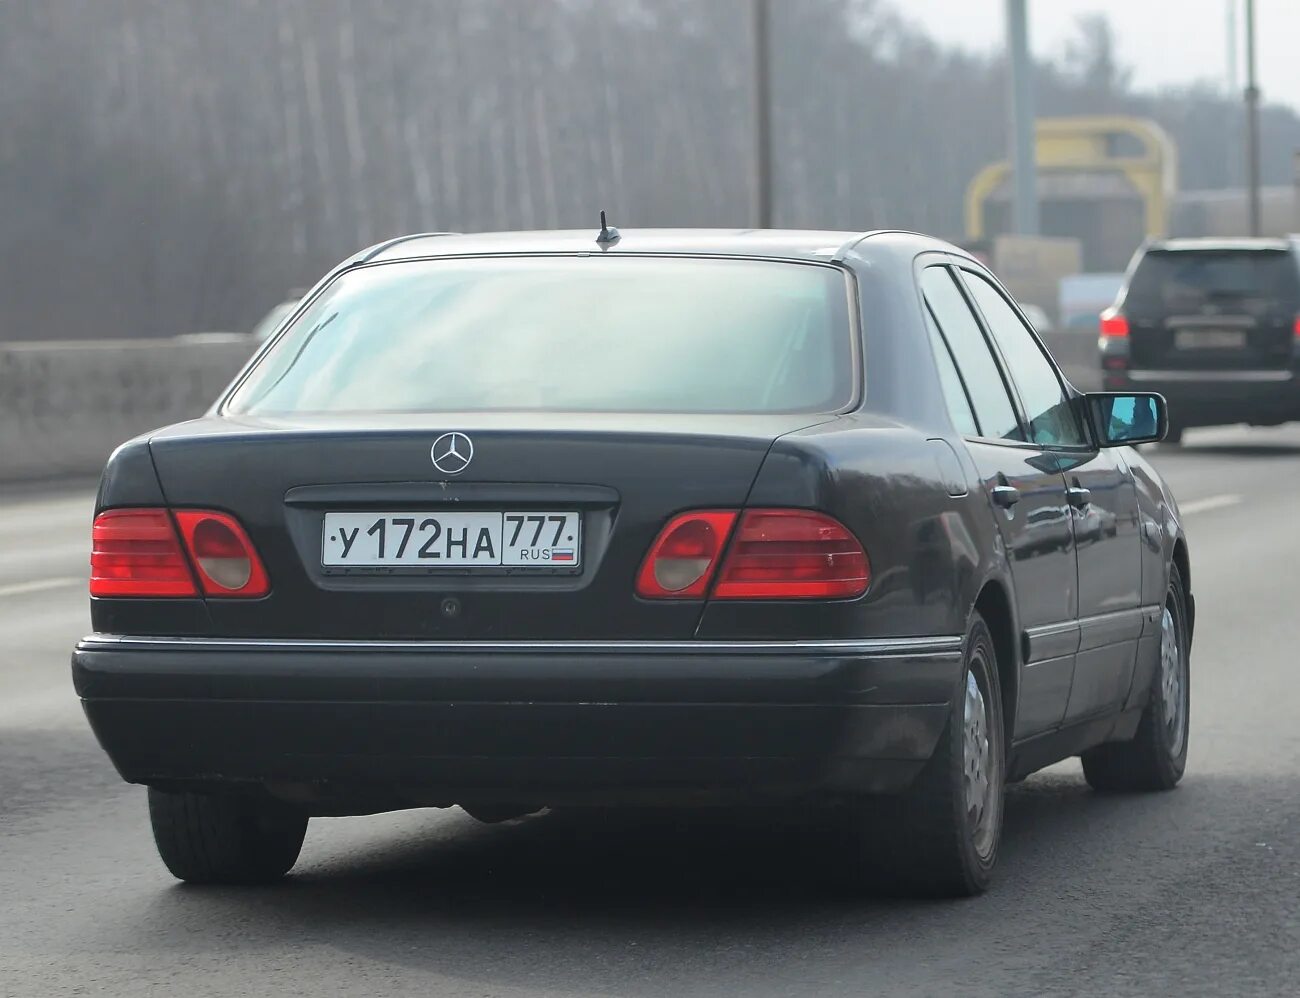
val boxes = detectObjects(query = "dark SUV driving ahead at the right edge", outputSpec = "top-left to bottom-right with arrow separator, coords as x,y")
1100,237 -> 1300,443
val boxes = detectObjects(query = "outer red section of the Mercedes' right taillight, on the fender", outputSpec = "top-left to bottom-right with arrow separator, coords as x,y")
714,509 -> 871,599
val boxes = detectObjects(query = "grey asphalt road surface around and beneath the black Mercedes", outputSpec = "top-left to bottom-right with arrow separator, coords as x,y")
0,429 -> 1300,998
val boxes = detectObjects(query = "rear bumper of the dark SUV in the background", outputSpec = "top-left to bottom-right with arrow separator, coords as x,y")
1105,370 -> 1300,426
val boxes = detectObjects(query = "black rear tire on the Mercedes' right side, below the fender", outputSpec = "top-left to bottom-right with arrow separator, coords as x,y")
854,613 -> 1006,897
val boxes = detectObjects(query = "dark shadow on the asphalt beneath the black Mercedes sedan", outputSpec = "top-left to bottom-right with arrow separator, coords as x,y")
101,772 -> 1237,994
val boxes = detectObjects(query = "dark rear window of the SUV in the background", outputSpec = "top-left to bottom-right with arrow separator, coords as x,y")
1125,250 -> 1300,311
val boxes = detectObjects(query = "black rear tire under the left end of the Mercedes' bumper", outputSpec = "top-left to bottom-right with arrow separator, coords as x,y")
150,787 -> 307,884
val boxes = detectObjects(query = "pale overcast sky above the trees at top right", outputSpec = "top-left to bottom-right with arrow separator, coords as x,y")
893,0 -> 1300,109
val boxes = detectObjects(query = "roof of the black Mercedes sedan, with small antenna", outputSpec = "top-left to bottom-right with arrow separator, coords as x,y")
356,226 -> 959,262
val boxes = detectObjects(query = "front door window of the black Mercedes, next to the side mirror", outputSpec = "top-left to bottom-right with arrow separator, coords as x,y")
962,269 -> 1088,447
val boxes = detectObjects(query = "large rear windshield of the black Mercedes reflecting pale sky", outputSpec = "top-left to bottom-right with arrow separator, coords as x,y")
225,256 -> 854,415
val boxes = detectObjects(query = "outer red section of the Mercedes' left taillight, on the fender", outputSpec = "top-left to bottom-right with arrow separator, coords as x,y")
90,509 -> 199,596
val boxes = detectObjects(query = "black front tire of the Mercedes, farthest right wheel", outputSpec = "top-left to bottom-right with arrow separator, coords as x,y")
1083,565 -> 1192,794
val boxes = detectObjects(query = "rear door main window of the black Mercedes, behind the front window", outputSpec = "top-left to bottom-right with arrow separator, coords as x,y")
920,266 -> 1024,441
